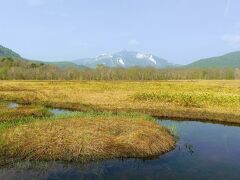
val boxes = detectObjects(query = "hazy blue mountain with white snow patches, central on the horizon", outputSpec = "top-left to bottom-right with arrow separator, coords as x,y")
73,51 -> 173,68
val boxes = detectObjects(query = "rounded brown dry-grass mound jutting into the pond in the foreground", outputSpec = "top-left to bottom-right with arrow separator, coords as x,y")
0,113 -> 175,162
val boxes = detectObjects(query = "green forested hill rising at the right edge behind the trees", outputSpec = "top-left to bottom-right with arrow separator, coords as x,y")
187,51 -> 240,68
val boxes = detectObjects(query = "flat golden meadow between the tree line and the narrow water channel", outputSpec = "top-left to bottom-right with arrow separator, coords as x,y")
0,80 -> 240,123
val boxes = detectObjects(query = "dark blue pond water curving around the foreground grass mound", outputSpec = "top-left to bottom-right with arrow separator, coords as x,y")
0,120 -> 240,180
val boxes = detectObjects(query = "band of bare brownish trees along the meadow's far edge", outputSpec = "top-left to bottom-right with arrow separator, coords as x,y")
0,58 -> 240,80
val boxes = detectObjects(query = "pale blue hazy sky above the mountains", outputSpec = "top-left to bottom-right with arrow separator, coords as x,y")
0,0 -> 240,64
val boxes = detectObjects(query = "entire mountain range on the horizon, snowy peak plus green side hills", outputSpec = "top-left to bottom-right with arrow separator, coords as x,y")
0,45 -> 240,68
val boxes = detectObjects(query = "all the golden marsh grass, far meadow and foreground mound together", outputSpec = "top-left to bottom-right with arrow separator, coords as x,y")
0,81 -> 240,161
